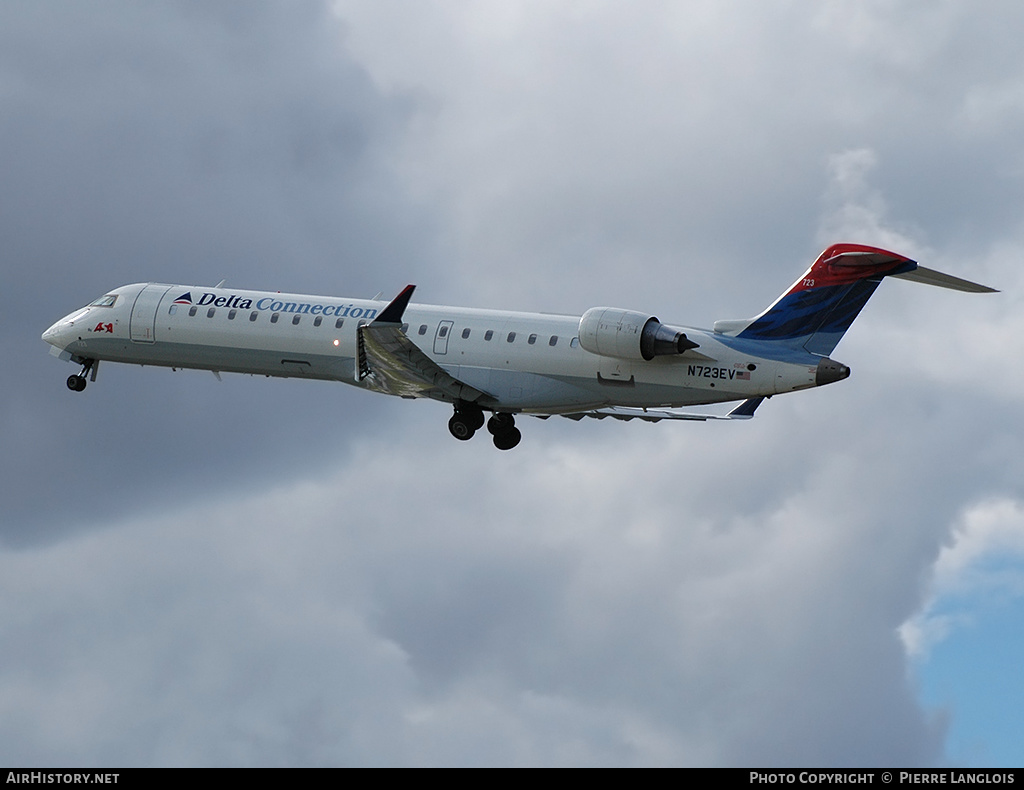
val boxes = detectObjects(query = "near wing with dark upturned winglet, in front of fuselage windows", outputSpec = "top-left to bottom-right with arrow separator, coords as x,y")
356,285 -> 490,402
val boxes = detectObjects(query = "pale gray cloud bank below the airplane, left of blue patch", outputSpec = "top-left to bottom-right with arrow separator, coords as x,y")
4,403 -> 1003,764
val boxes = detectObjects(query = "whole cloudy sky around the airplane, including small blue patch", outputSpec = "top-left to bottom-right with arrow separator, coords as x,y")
0,0 -> 1024,765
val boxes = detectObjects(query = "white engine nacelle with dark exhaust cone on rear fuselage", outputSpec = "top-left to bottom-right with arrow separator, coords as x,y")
580,307 -> 698,361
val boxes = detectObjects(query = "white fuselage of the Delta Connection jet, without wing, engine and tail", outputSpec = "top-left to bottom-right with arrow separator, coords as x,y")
43,284 -> 817,414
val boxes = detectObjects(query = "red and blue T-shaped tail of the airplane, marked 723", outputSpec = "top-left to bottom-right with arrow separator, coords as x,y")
715,239 -> 995,357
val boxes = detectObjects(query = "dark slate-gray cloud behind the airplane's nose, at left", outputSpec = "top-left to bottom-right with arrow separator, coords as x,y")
0,3 -> 431,544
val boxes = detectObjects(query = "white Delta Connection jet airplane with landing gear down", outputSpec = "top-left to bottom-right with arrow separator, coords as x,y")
42,244 -> 996,450
